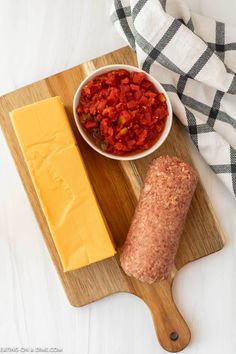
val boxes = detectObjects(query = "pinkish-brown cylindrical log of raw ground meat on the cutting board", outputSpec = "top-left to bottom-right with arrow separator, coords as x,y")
120,156 -> 198,283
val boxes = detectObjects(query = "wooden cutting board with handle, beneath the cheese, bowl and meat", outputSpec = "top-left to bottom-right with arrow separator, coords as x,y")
0,48 -> 224,352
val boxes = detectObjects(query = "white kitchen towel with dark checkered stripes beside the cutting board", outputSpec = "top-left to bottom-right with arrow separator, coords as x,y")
111,0 -> 236,196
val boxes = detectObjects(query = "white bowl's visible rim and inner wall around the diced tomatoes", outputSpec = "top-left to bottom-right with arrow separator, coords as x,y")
73,64 -> 173,160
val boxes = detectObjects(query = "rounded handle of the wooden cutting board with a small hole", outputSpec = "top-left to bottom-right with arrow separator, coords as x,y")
135,278 -> 191,353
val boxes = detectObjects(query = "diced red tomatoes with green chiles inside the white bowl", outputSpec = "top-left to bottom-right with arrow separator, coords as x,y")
77,70 -> 168,155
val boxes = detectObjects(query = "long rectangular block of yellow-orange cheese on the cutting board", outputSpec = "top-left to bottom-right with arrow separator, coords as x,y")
10,97 -> 115,271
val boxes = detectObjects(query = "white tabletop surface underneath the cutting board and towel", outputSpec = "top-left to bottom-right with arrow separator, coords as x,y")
0,0 -> 236,354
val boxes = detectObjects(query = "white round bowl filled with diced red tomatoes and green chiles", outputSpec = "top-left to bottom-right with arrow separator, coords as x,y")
73,65 -> 172,160
